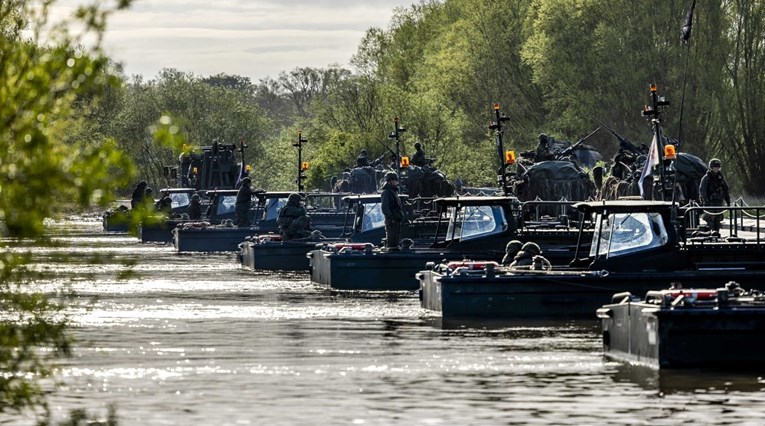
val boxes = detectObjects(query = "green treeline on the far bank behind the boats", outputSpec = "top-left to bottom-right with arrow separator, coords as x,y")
80,0 -> 765,195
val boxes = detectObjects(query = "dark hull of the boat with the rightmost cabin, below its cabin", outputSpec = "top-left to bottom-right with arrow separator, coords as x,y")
417,270 -> 765,319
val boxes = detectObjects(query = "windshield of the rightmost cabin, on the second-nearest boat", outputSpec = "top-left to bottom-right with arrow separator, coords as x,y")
590,213 -> 668,258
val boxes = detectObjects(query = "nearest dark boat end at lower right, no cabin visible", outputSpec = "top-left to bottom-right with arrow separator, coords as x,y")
597,281 -> 765,369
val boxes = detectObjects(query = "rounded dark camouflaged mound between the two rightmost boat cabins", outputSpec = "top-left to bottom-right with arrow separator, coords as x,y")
512,161 -> 596,201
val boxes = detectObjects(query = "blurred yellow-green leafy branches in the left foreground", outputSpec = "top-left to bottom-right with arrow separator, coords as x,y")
0,0 -> 133,410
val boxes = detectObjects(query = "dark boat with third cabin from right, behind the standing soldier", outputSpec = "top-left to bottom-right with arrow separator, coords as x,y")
239,194 -> 438,271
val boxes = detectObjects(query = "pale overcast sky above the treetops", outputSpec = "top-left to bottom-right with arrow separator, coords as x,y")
59,0 -> 415,82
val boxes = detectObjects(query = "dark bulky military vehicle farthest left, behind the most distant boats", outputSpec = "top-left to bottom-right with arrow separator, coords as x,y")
168,141 -> 247,190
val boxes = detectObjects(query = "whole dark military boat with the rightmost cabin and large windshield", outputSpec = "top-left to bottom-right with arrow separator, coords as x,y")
417,200 -> 765,318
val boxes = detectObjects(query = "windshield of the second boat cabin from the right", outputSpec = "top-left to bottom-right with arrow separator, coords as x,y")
446,206 -> 507,241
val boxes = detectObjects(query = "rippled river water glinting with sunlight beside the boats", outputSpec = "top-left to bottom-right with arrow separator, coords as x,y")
5,217 -> 765,425
